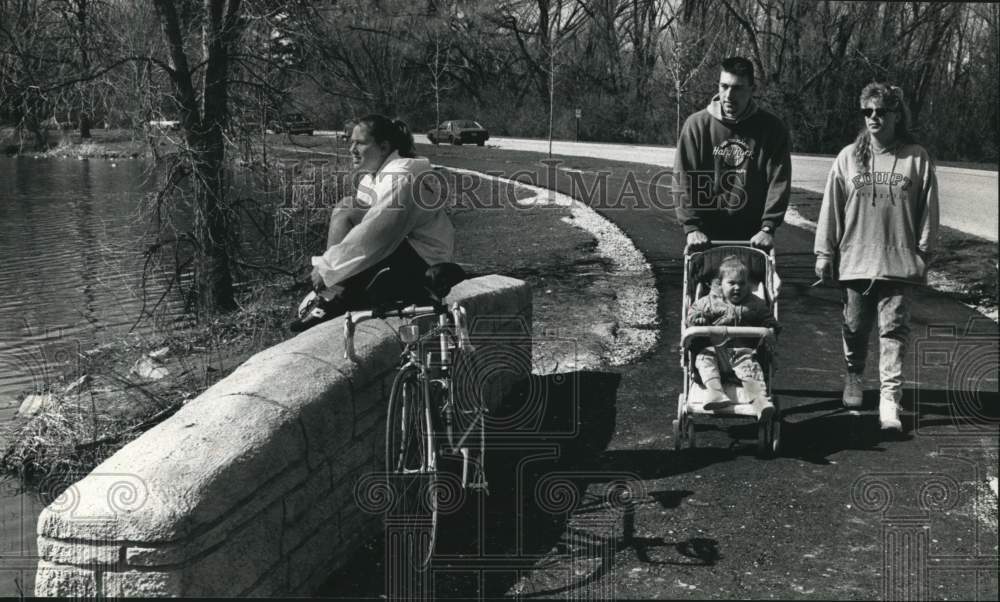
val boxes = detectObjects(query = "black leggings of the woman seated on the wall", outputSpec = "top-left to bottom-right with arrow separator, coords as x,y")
331,240 -> 430,311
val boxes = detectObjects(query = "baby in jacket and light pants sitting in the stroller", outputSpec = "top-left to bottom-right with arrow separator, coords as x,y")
688,255 -> 780,411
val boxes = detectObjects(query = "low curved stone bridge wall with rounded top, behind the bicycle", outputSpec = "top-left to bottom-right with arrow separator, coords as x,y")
35,276 -> 531,597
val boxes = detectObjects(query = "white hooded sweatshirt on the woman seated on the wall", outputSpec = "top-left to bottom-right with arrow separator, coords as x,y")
312,152 -> 455,286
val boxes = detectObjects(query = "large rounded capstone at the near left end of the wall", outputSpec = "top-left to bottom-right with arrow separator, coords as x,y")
38,395 -> 305,543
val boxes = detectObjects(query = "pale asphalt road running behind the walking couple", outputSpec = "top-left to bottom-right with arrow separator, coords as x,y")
488,138 -> 998,241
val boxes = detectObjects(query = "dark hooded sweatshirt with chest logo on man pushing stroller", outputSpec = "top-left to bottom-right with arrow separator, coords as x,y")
674,95 -> 792,240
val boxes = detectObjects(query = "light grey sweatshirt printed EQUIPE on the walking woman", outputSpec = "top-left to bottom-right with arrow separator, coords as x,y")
814,144 -> 939,283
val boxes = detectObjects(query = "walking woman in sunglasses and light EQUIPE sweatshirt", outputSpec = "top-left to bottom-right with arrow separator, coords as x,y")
814,83 -> 939,431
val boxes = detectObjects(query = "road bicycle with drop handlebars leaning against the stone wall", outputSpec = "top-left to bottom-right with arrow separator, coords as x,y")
344,268 -> 489,568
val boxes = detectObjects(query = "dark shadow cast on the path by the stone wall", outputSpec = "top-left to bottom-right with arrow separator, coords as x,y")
316,372 -> 628,599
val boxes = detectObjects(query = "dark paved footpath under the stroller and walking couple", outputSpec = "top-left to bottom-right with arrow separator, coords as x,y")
324,147 -> 1000,599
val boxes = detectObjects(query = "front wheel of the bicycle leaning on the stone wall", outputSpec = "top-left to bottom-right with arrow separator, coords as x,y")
385,366 -> 438,570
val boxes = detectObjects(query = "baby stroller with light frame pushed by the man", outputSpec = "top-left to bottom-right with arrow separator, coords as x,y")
672,241 -> 781,457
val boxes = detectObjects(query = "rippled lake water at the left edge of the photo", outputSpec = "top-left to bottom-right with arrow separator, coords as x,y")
0,157 -> 183,597
